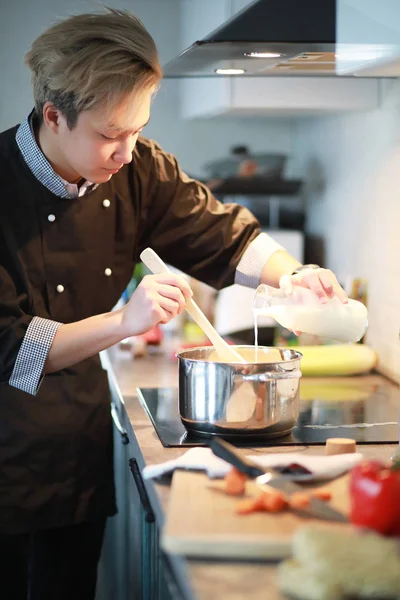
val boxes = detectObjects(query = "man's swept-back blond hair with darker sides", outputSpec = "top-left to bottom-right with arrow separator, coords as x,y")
25,7 -> 162,129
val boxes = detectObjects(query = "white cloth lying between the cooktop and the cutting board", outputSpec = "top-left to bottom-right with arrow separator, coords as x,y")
142,447 -> 363,481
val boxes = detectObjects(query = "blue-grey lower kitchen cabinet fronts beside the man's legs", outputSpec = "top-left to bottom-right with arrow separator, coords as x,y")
96,400 -> 180,600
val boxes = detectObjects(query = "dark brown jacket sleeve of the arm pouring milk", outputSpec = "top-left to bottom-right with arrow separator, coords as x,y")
135,140 -> 261,289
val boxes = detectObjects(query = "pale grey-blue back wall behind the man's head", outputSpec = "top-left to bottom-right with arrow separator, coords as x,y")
0,0 -> 292,176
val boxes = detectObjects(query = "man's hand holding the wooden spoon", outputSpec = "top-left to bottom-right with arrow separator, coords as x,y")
122,273 -> 193,337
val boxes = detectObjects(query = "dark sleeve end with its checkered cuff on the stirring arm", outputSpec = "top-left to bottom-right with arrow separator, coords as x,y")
0,256 -> 61,395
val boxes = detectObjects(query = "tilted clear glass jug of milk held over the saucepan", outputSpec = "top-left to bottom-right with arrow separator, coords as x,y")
253,284 -> 368,342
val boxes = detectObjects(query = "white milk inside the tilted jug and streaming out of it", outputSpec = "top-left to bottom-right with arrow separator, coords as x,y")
254,299 -> 368,344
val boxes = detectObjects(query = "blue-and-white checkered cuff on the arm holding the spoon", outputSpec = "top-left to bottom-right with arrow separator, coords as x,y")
8,317 -> 62,396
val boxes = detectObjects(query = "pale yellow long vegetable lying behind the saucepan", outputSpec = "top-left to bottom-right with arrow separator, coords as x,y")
295,344 -> 378,377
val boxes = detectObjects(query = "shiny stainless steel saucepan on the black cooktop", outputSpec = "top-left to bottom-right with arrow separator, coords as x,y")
177,346 -> 302,439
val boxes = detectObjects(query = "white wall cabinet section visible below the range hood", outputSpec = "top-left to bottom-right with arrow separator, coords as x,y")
180,76 -> 379,119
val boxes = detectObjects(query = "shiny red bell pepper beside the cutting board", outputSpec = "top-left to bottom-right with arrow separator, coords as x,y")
350,460 -> 400,536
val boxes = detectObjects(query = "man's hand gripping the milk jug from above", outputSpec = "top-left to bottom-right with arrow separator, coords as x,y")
279,268 -> 349,304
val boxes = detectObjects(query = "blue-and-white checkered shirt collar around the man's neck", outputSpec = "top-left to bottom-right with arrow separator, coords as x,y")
15,110 -> 98,199
